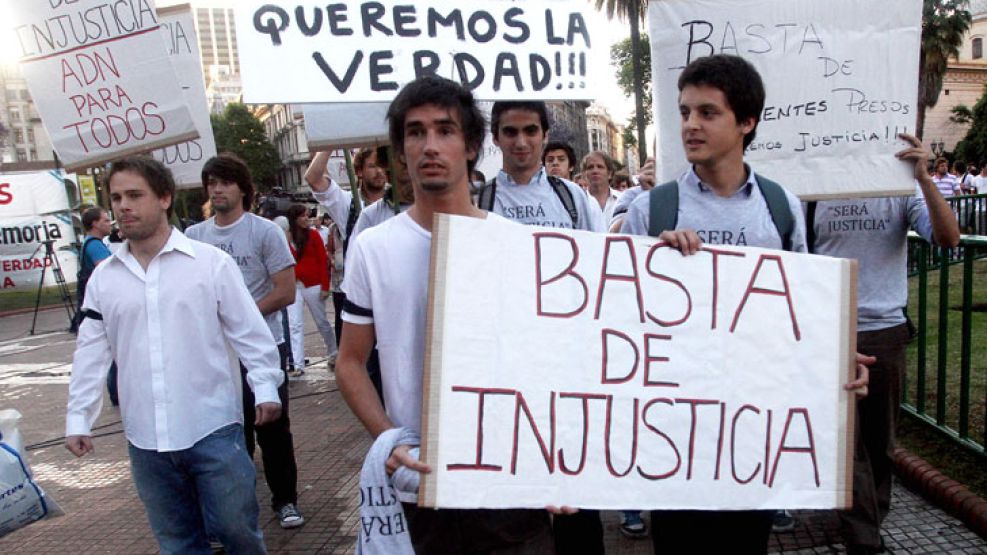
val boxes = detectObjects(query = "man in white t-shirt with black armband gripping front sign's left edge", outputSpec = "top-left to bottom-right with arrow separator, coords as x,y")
336,77 -> 552,554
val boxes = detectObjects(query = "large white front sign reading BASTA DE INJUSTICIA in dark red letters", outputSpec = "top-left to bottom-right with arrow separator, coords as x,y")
419,215 -> 856,510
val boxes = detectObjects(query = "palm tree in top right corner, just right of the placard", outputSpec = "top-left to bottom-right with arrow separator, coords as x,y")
916,0 -> 973,138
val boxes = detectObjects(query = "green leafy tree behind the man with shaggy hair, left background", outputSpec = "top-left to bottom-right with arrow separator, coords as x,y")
209,103 -> 281,190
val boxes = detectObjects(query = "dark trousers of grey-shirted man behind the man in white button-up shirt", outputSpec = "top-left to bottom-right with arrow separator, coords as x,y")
240,342 -> 298,510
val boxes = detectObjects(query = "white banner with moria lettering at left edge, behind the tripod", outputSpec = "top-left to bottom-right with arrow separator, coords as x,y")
0,171 -> 78,291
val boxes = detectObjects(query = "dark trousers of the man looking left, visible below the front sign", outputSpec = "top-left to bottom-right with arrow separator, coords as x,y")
651,511 -> 774,555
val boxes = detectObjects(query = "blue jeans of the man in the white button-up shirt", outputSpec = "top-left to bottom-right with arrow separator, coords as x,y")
129,424 -> 266,555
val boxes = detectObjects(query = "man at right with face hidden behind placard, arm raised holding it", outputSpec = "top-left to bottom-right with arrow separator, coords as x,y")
806,135 -> 960,555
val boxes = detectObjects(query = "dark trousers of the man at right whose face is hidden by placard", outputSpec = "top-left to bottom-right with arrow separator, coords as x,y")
839,324 -> 908,547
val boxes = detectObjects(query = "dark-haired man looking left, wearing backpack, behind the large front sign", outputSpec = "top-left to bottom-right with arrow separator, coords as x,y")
621,54 -> 872,553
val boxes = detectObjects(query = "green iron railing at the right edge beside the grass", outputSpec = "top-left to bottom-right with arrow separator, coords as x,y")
902,234 -> 987,458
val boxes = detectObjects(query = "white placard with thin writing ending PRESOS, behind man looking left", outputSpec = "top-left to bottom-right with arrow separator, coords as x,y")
648,0 -> 922,199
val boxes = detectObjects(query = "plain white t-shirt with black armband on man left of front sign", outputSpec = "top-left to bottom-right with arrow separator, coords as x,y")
343,213 -> 503,432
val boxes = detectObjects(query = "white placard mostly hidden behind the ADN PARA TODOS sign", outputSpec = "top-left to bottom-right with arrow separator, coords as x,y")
153,4 -> 216,189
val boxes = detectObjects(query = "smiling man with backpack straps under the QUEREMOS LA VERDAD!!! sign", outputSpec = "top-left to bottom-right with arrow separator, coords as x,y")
477,101 -> 603,231
